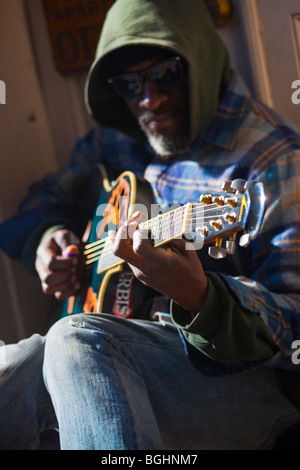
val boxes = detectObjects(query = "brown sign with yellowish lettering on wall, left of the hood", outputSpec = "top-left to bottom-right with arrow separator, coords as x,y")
43,0 -> 114,73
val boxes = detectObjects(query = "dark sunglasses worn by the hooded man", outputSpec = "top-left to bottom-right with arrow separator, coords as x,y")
108,56 -> 183,98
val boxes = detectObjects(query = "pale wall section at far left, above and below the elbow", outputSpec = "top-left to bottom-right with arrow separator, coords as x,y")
0,0 -> 57,343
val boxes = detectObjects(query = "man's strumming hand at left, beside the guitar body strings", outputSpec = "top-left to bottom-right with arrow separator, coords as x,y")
35,229 -> 80,299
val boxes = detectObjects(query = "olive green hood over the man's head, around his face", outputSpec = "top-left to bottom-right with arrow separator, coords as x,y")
86,0 -> 230,143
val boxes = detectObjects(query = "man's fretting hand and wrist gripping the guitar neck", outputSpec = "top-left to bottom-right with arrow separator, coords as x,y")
109,213 -> 208,312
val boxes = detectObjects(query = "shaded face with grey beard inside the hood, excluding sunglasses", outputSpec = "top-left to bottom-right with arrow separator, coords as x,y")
110,57 -> 189,156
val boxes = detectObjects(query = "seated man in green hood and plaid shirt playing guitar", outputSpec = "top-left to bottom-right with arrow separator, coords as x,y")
0,0 -> 300,450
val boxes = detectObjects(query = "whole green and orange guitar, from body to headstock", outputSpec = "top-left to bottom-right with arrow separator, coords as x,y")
62,166 -> 265,318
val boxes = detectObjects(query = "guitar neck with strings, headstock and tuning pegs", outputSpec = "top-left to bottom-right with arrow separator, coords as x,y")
84,183 -> 264,273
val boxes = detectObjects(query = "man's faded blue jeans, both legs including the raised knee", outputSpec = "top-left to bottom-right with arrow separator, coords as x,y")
0,315 -> 300,450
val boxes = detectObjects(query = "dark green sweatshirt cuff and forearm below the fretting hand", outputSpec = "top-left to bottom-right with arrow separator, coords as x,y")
171,273 -> 278,363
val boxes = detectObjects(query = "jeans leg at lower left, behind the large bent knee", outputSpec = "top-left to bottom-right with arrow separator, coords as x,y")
0,335 -> 57,450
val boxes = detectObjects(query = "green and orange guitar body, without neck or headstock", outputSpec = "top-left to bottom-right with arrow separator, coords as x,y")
61,166 -> 153,318
